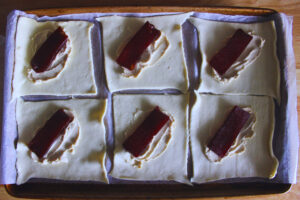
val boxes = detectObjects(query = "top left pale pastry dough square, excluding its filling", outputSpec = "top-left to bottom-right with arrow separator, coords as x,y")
13,16 -> 97,98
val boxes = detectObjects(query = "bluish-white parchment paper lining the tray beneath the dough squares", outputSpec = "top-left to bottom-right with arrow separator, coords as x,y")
0,11 -> 298,184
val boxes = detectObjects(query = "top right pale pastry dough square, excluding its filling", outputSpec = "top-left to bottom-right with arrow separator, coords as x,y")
189,17 -> 280,100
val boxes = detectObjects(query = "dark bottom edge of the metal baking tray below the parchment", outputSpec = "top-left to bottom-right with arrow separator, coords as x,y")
5,182 -> 292,199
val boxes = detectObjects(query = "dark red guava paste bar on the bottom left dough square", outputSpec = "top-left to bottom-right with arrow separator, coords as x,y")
28,109 -> 74,158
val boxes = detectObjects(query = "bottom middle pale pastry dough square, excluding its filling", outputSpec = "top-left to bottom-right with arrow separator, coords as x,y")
110,94 -> 189,183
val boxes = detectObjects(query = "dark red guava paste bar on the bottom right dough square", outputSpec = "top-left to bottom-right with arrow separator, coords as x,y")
207,106 -> 250,158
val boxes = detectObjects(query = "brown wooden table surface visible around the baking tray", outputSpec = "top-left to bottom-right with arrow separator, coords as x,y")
0,0 -> 300,200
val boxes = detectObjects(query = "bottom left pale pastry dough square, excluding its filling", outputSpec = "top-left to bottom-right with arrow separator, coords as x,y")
16,98 -> 107,184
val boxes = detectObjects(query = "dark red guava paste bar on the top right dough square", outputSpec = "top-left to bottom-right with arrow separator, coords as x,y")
209,29 -> 253,76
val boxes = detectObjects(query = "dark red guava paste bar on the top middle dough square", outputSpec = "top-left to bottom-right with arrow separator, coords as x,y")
117,22 -> 160,70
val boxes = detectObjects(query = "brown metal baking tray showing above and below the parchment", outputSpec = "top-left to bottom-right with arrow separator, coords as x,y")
5,6 -> 291,199
